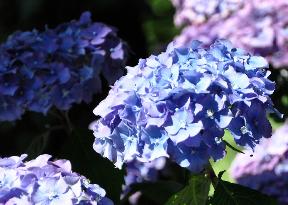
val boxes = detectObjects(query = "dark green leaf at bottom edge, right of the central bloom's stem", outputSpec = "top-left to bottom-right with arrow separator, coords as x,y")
211,179 -> 277,205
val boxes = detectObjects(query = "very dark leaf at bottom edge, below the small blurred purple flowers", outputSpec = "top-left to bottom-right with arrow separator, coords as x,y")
123,181 -> 183,205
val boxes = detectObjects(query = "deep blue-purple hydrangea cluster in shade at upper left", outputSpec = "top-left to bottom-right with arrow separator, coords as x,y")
0,12 -> 126,121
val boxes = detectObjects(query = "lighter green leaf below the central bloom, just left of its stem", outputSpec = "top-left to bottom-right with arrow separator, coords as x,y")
166,175 -> 211,205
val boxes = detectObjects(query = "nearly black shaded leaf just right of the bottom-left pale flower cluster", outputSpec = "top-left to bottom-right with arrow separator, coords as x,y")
60,129 -> 124,204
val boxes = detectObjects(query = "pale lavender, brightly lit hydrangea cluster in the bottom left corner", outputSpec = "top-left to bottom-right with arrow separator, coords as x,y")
0,155 -> 113,205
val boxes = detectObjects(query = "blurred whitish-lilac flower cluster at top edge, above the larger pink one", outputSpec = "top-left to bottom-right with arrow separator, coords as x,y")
171,0 -> 244,26
